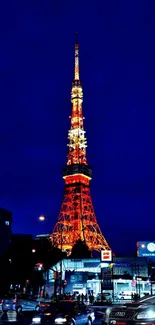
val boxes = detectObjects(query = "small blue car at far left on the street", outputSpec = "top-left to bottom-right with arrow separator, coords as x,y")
2,294 -> 40,313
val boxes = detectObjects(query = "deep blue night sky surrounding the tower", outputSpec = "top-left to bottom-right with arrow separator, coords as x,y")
0,0 -> 155,254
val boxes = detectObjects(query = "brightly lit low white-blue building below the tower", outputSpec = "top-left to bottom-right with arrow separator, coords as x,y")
47,257 -> 150,296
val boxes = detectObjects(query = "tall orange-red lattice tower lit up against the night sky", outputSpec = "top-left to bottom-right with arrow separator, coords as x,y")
51,37 -> 110,253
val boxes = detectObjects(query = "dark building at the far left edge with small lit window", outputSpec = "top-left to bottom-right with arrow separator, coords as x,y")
0,208 -> 12,256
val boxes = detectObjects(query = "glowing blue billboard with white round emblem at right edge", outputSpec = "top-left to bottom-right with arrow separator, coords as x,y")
137,241 -> 155,258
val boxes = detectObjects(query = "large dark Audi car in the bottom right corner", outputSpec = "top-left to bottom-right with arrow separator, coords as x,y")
102,295 -> 155,325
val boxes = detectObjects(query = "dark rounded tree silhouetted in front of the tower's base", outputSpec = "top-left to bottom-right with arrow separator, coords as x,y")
70,239 -> 91,258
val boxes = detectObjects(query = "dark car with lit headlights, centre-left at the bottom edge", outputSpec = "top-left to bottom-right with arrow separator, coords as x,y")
32,300 -> 95,325
